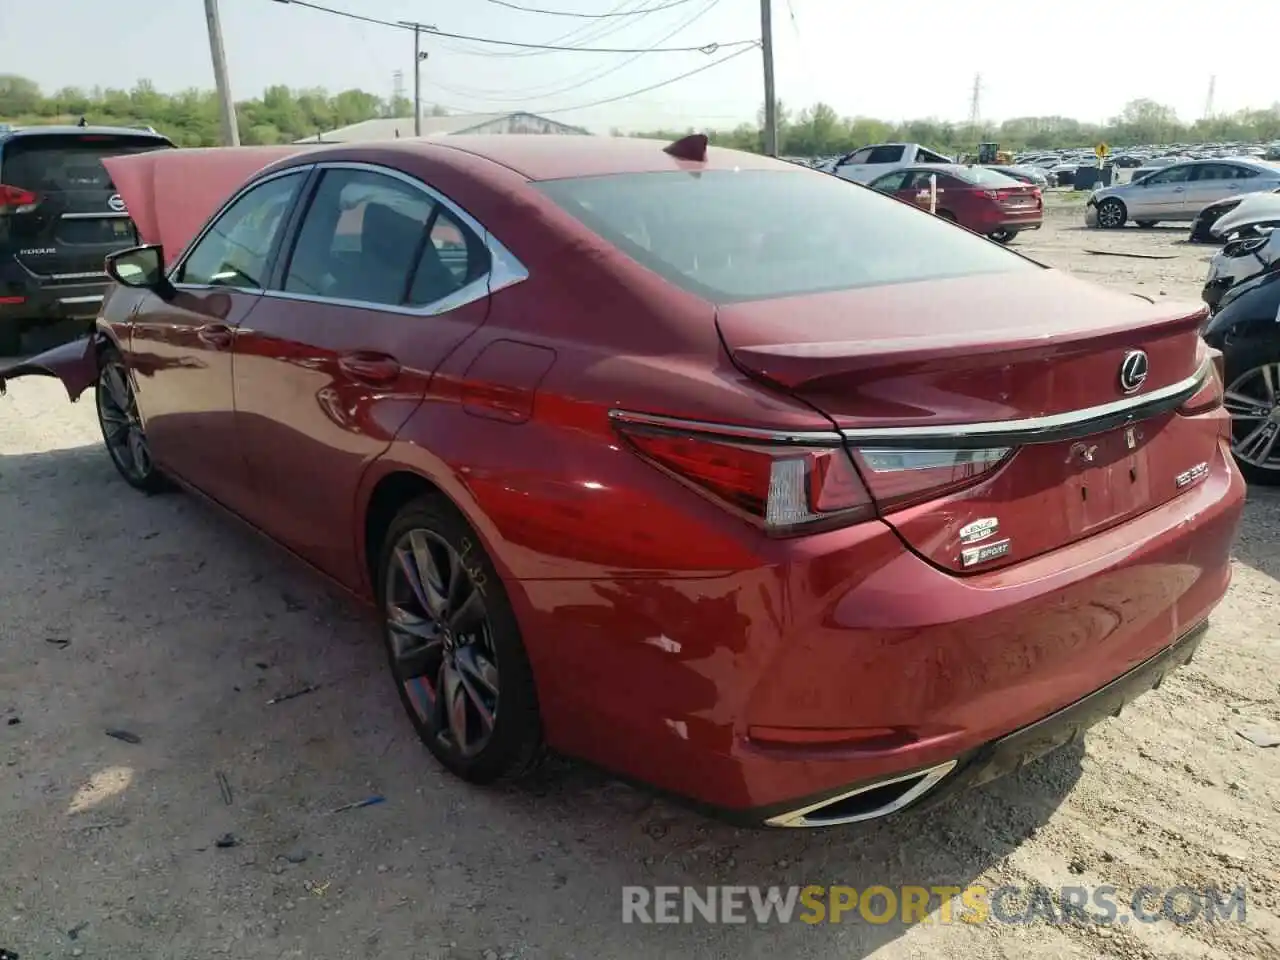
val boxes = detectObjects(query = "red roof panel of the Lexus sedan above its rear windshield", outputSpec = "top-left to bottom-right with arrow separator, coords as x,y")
384,133 -> 797,180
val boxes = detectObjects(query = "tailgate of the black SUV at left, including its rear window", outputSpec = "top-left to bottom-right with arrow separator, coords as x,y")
0,131 -> 173,283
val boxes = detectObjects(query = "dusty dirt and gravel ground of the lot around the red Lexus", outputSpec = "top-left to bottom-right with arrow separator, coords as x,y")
0,200 -> 1280,960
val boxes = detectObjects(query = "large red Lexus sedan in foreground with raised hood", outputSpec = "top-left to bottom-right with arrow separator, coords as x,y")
0,136 -> 1244,827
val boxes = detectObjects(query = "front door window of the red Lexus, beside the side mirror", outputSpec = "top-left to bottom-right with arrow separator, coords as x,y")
175,172 -> 303,289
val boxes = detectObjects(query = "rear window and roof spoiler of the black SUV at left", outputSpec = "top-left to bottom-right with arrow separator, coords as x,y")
0,134 -> 170,193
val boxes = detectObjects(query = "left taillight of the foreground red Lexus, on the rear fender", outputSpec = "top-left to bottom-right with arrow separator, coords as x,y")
617,422 -> 876,536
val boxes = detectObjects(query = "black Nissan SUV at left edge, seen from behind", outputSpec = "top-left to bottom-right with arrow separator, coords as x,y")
0,125 -> 173,356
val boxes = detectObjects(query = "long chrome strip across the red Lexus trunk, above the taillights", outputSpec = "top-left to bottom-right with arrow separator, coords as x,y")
609,360 -> 1213,449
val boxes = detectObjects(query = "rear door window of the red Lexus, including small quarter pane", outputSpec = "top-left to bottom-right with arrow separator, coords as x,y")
284,169 -> 488,306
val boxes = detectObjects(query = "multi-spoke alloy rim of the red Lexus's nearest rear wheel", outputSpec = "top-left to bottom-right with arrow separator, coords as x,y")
384,529 -> 499,758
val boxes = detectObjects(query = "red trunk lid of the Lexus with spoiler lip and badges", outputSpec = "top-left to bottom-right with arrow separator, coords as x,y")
718,270 -> 1219,572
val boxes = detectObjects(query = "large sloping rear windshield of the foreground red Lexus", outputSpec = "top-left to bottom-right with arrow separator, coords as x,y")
536,170 -> 1038,303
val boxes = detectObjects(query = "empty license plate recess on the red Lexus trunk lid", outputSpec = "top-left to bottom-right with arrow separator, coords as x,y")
1065,424 -> 1152,535
